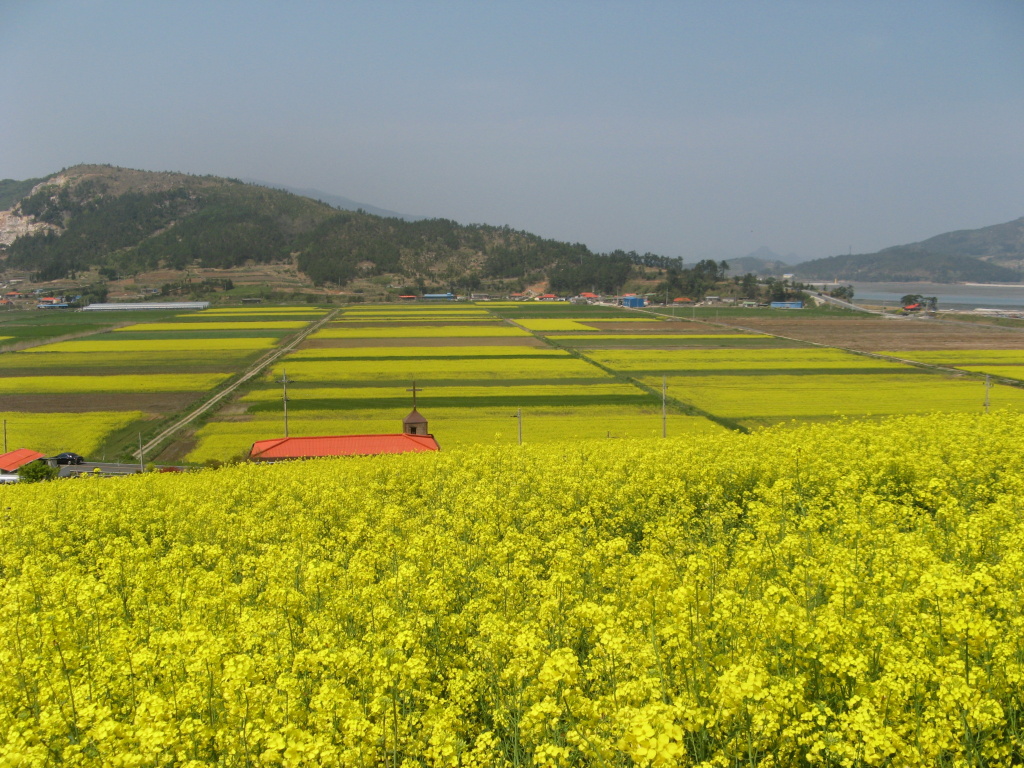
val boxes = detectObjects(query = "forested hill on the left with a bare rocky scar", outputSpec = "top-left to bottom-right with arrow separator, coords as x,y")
0,166 -> 643,293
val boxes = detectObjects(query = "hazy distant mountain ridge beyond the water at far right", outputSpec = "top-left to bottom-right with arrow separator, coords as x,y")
794,217 -> 1024,283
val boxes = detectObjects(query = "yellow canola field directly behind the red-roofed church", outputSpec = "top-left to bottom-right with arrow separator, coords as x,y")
186,405 -> 724,463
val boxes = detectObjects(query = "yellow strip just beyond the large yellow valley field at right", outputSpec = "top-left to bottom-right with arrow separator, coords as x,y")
586,349 -> 915,373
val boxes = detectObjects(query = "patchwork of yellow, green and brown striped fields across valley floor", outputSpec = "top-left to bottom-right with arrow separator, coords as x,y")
0,302 -> 1024,462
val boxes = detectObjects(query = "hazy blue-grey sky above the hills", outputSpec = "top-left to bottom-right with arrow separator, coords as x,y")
0,0 -> 1024,260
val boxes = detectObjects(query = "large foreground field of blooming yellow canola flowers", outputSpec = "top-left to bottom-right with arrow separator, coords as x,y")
0,414 -> 1024,768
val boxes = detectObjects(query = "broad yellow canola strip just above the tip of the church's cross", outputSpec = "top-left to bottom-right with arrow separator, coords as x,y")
272,357 -> 610,382
